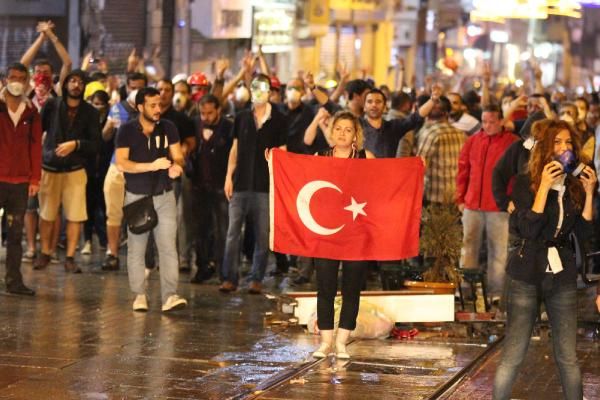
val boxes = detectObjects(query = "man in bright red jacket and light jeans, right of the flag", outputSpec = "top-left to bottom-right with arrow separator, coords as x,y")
456,106 -> 518,303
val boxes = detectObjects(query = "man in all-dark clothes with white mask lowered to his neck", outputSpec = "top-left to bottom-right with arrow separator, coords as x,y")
189,94 -> 233,283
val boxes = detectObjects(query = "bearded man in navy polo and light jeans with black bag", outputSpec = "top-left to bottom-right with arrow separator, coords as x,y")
115,88 -> 187,311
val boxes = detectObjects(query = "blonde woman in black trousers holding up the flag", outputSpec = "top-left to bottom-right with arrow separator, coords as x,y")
313,111 -> 375,359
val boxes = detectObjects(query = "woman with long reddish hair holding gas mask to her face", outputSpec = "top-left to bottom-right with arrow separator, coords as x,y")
493,120 -> 597,400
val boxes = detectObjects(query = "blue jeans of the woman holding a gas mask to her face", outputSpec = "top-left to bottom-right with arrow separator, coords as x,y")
493,273 -> 583,400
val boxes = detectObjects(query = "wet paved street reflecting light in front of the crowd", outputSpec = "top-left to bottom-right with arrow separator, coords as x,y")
0,250 -> 600,400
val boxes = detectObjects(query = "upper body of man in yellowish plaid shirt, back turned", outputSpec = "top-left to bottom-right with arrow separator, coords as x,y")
417,96 -> 467,204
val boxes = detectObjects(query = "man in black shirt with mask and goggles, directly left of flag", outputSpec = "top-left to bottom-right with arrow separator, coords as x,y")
219,74 -> 288,294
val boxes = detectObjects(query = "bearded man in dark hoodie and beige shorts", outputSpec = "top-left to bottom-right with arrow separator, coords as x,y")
33,70 -> 100,273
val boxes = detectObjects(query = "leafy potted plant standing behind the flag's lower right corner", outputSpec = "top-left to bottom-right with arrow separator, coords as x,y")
404,203 -> 462,293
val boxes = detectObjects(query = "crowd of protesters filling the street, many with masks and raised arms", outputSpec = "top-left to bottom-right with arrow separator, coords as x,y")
0,21 -> 600,392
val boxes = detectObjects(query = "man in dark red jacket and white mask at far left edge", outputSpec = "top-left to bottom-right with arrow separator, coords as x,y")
0,64 -> 42,296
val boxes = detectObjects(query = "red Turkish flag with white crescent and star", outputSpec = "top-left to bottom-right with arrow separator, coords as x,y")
269,149 -> 425,261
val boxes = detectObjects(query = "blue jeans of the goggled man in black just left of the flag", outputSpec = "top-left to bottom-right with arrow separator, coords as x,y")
222,192 -> 269,286
